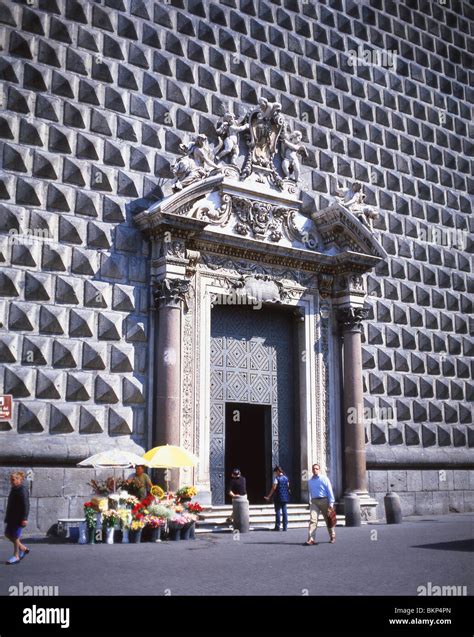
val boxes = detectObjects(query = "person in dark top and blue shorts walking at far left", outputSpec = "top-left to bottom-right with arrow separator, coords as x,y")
5,471 -> 30,565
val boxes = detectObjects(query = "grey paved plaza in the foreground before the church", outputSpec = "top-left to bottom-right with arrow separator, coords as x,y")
0,514 -> 474,596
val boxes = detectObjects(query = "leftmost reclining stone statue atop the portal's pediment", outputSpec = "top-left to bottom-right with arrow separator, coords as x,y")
171,135 -> 219,191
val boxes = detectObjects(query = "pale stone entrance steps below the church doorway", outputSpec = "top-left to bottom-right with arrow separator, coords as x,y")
196,504 -> 345,533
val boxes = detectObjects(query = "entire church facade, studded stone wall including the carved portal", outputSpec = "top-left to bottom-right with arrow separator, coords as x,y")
0,0 -> 474,531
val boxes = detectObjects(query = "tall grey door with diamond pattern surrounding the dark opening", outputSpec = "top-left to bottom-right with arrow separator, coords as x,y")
210,306 -> 297,504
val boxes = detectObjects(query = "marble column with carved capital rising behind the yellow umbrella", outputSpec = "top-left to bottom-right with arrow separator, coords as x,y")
153,279 -> 189,489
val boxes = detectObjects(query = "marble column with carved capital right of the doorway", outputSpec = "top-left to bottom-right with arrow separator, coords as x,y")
337,307 -> 368,495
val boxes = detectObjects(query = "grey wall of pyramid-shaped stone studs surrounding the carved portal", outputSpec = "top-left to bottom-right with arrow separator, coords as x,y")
0,0 -> 474,528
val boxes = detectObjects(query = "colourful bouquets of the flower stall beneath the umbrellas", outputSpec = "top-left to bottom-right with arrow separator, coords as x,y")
79,478 -> 203,544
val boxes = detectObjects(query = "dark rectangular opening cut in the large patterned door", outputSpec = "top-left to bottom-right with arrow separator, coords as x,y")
225,403 -> 272,504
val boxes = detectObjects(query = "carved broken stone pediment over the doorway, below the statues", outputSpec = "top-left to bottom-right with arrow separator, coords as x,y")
135,173 -> 385,267
